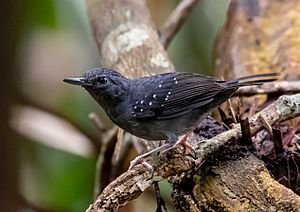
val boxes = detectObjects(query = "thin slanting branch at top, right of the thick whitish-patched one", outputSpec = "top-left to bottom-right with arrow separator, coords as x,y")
159,0 -> 199,49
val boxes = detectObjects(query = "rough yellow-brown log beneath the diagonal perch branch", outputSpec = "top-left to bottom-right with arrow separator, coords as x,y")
173,155 -> 300,212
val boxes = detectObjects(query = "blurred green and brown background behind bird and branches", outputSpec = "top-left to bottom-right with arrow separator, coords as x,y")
0,0 -> 229,212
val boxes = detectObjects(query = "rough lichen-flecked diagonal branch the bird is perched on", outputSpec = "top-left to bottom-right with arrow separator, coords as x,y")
87,94 -> 300,211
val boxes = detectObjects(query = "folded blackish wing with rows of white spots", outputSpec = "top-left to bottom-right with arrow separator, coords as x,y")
132,73 -> 225,120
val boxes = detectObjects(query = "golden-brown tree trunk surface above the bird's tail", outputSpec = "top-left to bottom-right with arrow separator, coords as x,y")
215,0 -> 300,80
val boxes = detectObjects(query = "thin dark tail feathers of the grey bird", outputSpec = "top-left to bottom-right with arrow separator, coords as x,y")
224,73 -> 280,89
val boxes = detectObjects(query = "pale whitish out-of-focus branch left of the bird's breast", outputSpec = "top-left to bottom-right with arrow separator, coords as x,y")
10,105 -> 98,158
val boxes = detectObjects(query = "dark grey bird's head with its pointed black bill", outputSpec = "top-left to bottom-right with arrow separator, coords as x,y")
64,68 -> 129,106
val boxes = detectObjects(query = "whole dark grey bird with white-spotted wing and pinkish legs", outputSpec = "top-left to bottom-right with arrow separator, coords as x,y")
63,67 -> 279,167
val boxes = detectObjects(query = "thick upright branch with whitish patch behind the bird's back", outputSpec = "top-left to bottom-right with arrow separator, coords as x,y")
87,0 -> 175,78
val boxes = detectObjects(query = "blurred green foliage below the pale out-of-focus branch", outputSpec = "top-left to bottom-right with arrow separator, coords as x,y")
21,140 -> 95,211
